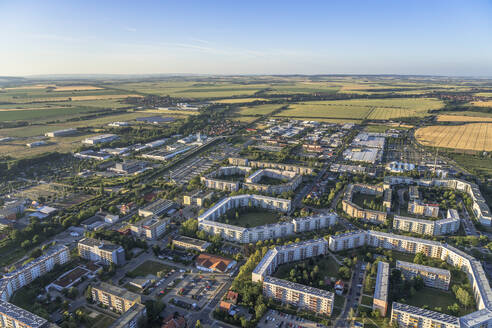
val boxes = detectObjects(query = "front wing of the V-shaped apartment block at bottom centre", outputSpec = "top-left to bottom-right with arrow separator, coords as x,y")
263,276 -> 335,316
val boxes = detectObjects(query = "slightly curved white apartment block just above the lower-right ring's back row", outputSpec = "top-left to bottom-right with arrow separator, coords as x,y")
393,213 -> 460,236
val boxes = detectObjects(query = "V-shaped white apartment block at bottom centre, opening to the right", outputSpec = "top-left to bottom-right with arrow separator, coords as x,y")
251,239 -> 335,316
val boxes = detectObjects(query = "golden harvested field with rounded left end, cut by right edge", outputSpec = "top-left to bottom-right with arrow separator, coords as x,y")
415,123 -> 492,151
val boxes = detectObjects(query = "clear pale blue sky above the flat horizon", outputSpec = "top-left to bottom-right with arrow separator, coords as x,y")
0,0 -> 492,76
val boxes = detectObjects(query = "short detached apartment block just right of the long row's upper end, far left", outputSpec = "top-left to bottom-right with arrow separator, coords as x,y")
77,238 -> 125,265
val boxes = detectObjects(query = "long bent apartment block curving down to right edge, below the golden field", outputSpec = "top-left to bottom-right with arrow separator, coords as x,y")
384,176 -> 492,226
